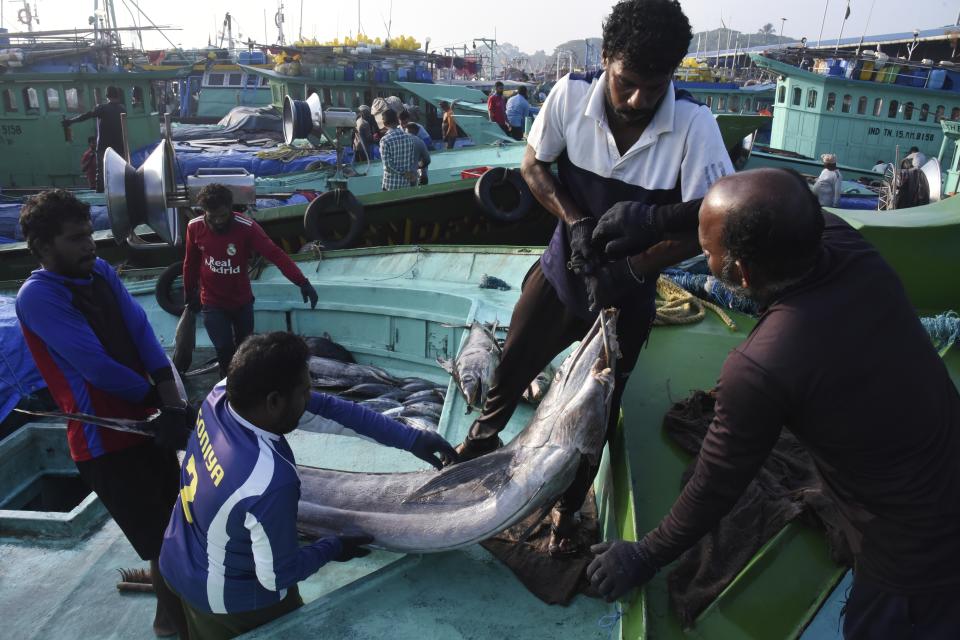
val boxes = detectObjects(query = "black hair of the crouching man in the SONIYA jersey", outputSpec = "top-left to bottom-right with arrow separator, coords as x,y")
227,331 -> 310,409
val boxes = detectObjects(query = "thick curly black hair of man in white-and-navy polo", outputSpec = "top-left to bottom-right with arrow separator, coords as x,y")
603,0 -> 693,74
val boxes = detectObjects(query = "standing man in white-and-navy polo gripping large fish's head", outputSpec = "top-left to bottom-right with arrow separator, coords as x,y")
459,0 -> 733,554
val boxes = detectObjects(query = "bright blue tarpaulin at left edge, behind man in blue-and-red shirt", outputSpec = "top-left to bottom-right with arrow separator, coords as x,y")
0,296 -> 47,421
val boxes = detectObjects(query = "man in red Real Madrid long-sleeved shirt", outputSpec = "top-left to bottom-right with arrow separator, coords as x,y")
183,184 -> 317,377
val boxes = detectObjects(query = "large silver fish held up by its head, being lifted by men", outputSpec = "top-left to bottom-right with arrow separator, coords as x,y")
297,309 -> 619,553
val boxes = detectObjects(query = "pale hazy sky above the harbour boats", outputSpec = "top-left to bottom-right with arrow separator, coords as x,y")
0,0 -> 960,53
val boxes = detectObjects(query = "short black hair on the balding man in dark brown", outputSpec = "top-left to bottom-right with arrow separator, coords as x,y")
721,169 -> 824,283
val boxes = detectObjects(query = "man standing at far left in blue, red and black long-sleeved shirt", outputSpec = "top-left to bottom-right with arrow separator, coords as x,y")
17,189 -> 193,638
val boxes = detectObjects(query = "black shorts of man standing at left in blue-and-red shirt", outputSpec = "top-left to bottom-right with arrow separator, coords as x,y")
76,443 -> 180,560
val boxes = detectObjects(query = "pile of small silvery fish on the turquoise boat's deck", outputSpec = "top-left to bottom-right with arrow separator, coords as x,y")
309,356 -> 447,431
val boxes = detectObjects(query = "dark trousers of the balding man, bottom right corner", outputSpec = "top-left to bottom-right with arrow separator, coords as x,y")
843,574 -> 960,640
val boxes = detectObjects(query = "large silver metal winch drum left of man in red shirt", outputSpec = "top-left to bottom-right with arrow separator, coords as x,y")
103,141 -> 181,246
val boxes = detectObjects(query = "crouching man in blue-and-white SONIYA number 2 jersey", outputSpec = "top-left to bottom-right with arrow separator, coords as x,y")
160,332 -> 456,639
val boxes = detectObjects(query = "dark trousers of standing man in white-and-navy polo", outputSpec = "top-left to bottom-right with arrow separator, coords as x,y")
467,262 -> 654,513
